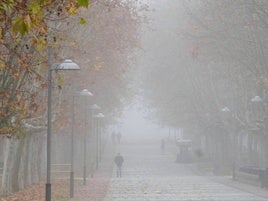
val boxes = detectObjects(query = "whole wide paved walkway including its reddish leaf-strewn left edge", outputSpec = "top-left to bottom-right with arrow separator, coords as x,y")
70,138 -> 268,201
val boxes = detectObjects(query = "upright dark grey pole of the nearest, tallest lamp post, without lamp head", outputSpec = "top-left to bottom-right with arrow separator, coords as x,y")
46,67 -> 52,201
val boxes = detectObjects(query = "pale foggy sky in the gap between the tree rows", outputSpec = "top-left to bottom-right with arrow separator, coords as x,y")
109,0 -> 177,140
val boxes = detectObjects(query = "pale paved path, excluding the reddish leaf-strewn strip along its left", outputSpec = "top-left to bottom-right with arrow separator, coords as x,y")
101,141 -> 267,201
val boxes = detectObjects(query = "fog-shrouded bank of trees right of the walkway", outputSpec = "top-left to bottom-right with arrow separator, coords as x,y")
142,0 -> 268,176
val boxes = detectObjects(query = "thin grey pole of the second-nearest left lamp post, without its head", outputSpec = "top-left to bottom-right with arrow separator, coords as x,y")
70,95 -> 74,198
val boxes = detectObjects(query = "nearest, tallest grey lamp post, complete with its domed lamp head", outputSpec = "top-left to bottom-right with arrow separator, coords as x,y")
46,58 -> 80,201
